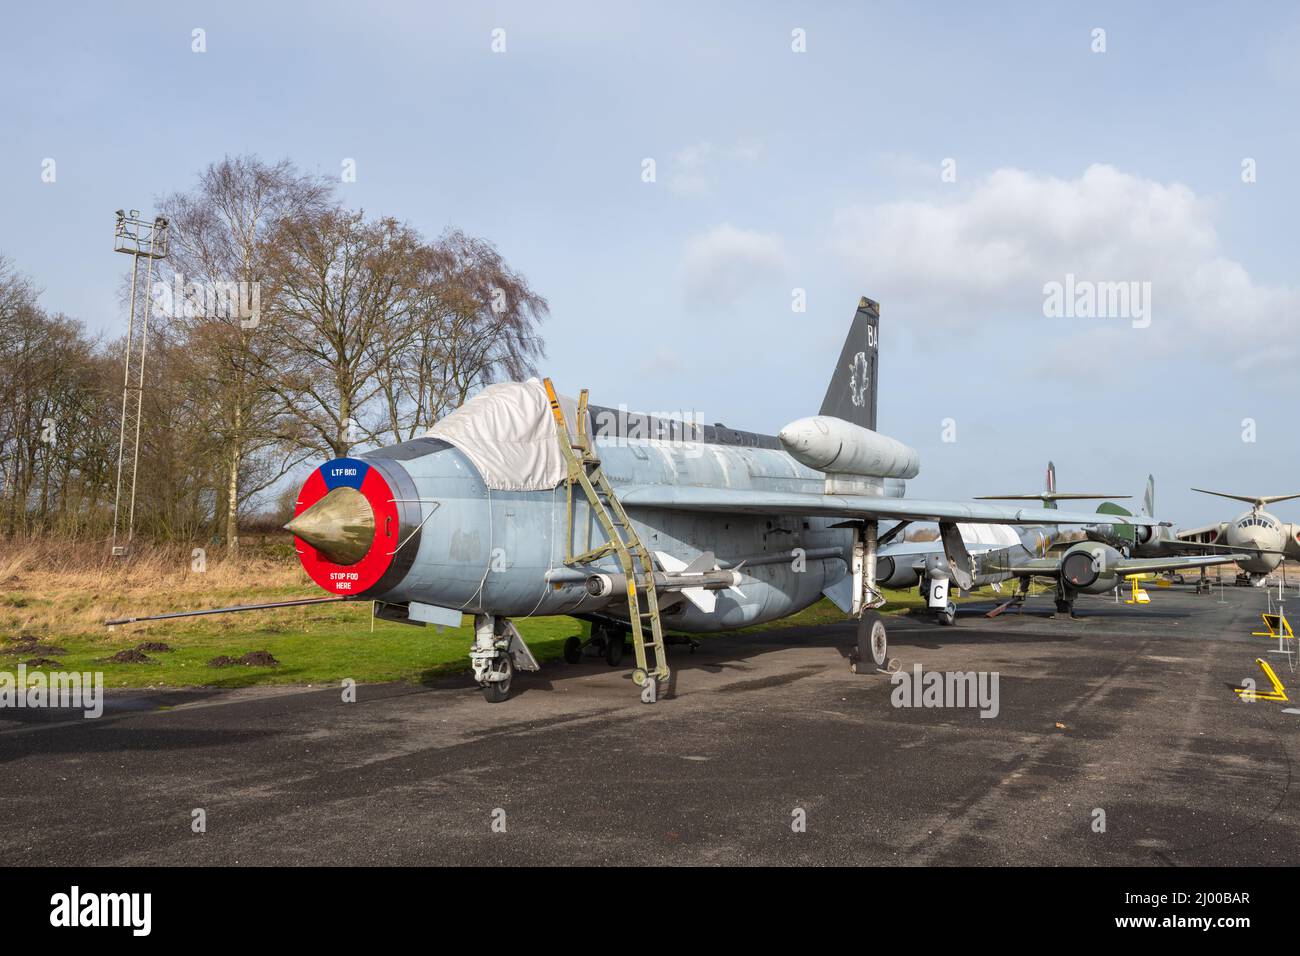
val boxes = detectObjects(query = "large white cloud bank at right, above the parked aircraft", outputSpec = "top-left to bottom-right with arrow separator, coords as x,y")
832,165 -> 1300,354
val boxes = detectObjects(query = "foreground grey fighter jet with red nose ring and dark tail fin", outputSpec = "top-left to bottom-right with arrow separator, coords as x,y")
116,298 -> 1149,702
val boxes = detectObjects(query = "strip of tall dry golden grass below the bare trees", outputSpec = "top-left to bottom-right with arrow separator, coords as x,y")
0,541 -> 312,637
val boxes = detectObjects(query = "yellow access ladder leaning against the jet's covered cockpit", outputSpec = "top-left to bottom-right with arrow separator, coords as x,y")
543,378 -> 671,687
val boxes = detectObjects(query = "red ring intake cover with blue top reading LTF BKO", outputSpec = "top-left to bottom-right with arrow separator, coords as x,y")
294,458 -> 400,594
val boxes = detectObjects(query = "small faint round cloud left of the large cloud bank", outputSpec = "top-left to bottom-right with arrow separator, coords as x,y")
681,222 -> 787,307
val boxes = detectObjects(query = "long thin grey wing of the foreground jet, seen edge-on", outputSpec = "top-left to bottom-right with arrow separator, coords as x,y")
618,485 -> 1158,527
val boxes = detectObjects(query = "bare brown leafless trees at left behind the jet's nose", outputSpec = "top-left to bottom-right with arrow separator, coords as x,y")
0,156 -> 547,551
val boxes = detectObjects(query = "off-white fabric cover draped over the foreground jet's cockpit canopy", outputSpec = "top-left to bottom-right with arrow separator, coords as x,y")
429,378 -> 577,492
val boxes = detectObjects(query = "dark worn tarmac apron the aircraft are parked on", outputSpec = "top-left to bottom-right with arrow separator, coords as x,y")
0,587 -> 1300,866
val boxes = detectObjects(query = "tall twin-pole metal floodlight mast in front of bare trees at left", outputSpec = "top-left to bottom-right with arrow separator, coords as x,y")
112,209 -> 168,557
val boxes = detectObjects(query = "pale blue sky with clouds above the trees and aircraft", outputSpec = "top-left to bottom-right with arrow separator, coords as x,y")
0,0 -> 1300,524
